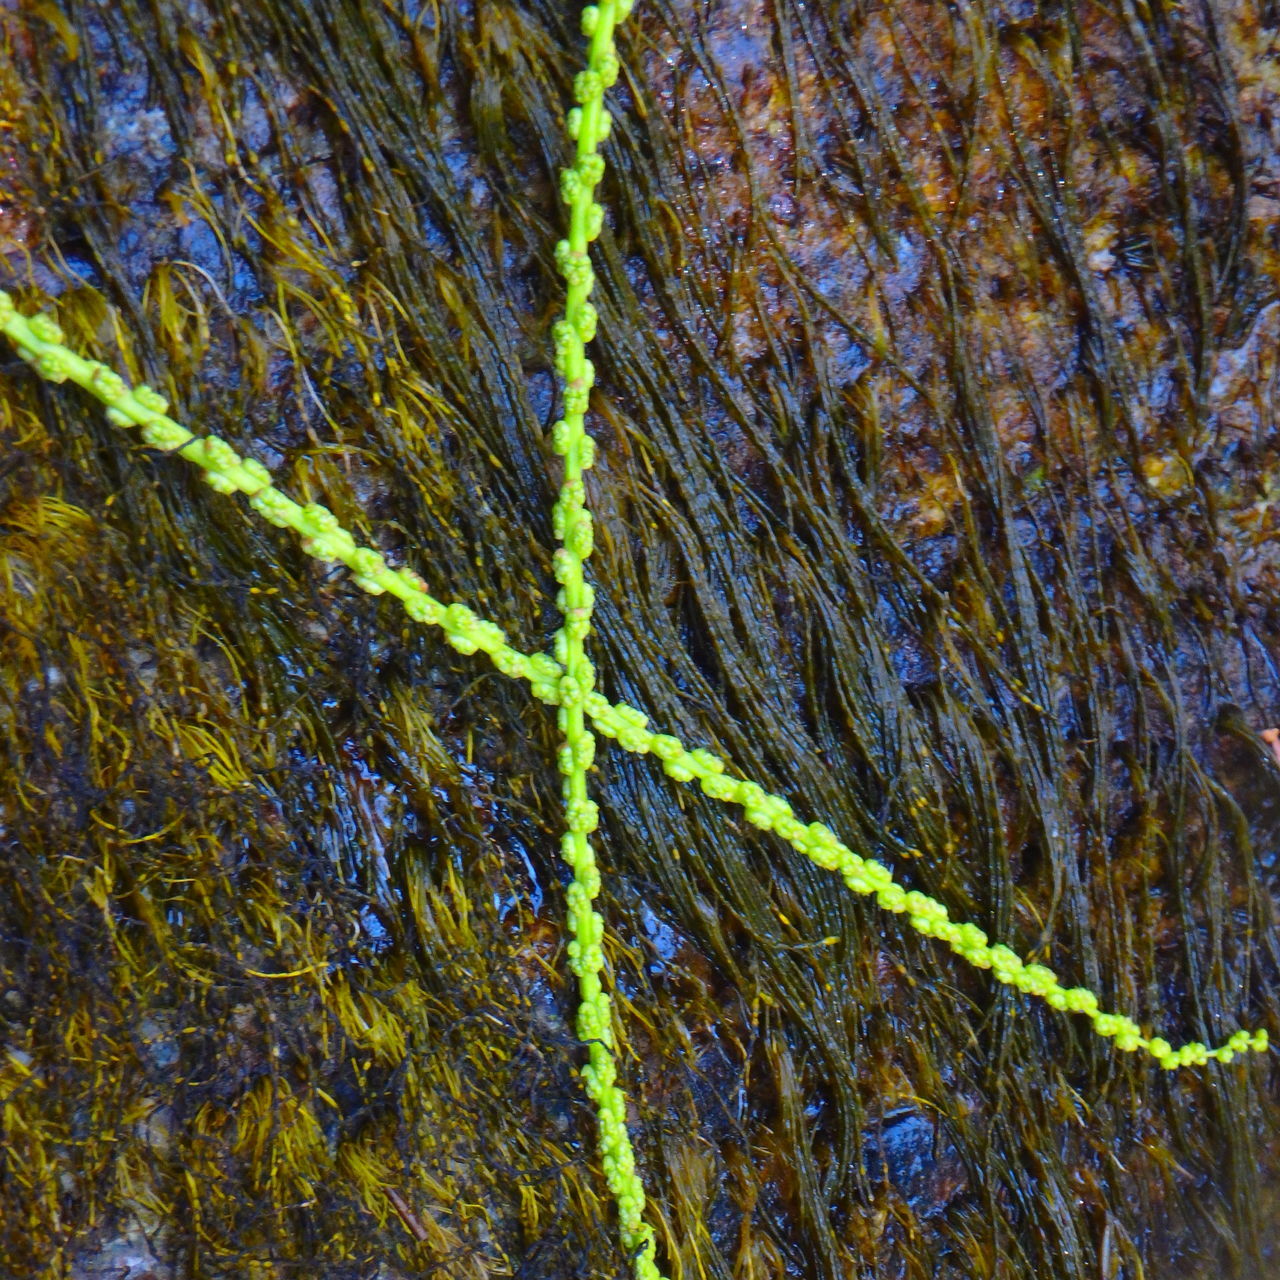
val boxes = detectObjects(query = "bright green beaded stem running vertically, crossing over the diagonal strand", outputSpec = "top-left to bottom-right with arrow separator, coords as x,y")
552,0 -> 659,1280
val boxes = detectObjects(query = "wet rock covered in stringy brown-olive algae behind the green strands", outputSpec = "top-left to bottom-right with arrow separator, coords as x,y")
0,0 -> 1280,1277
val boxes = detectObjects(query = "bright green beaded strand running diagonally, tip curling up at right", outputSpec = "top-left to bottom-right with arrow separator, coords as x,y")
0,292 -> 1267,1069
